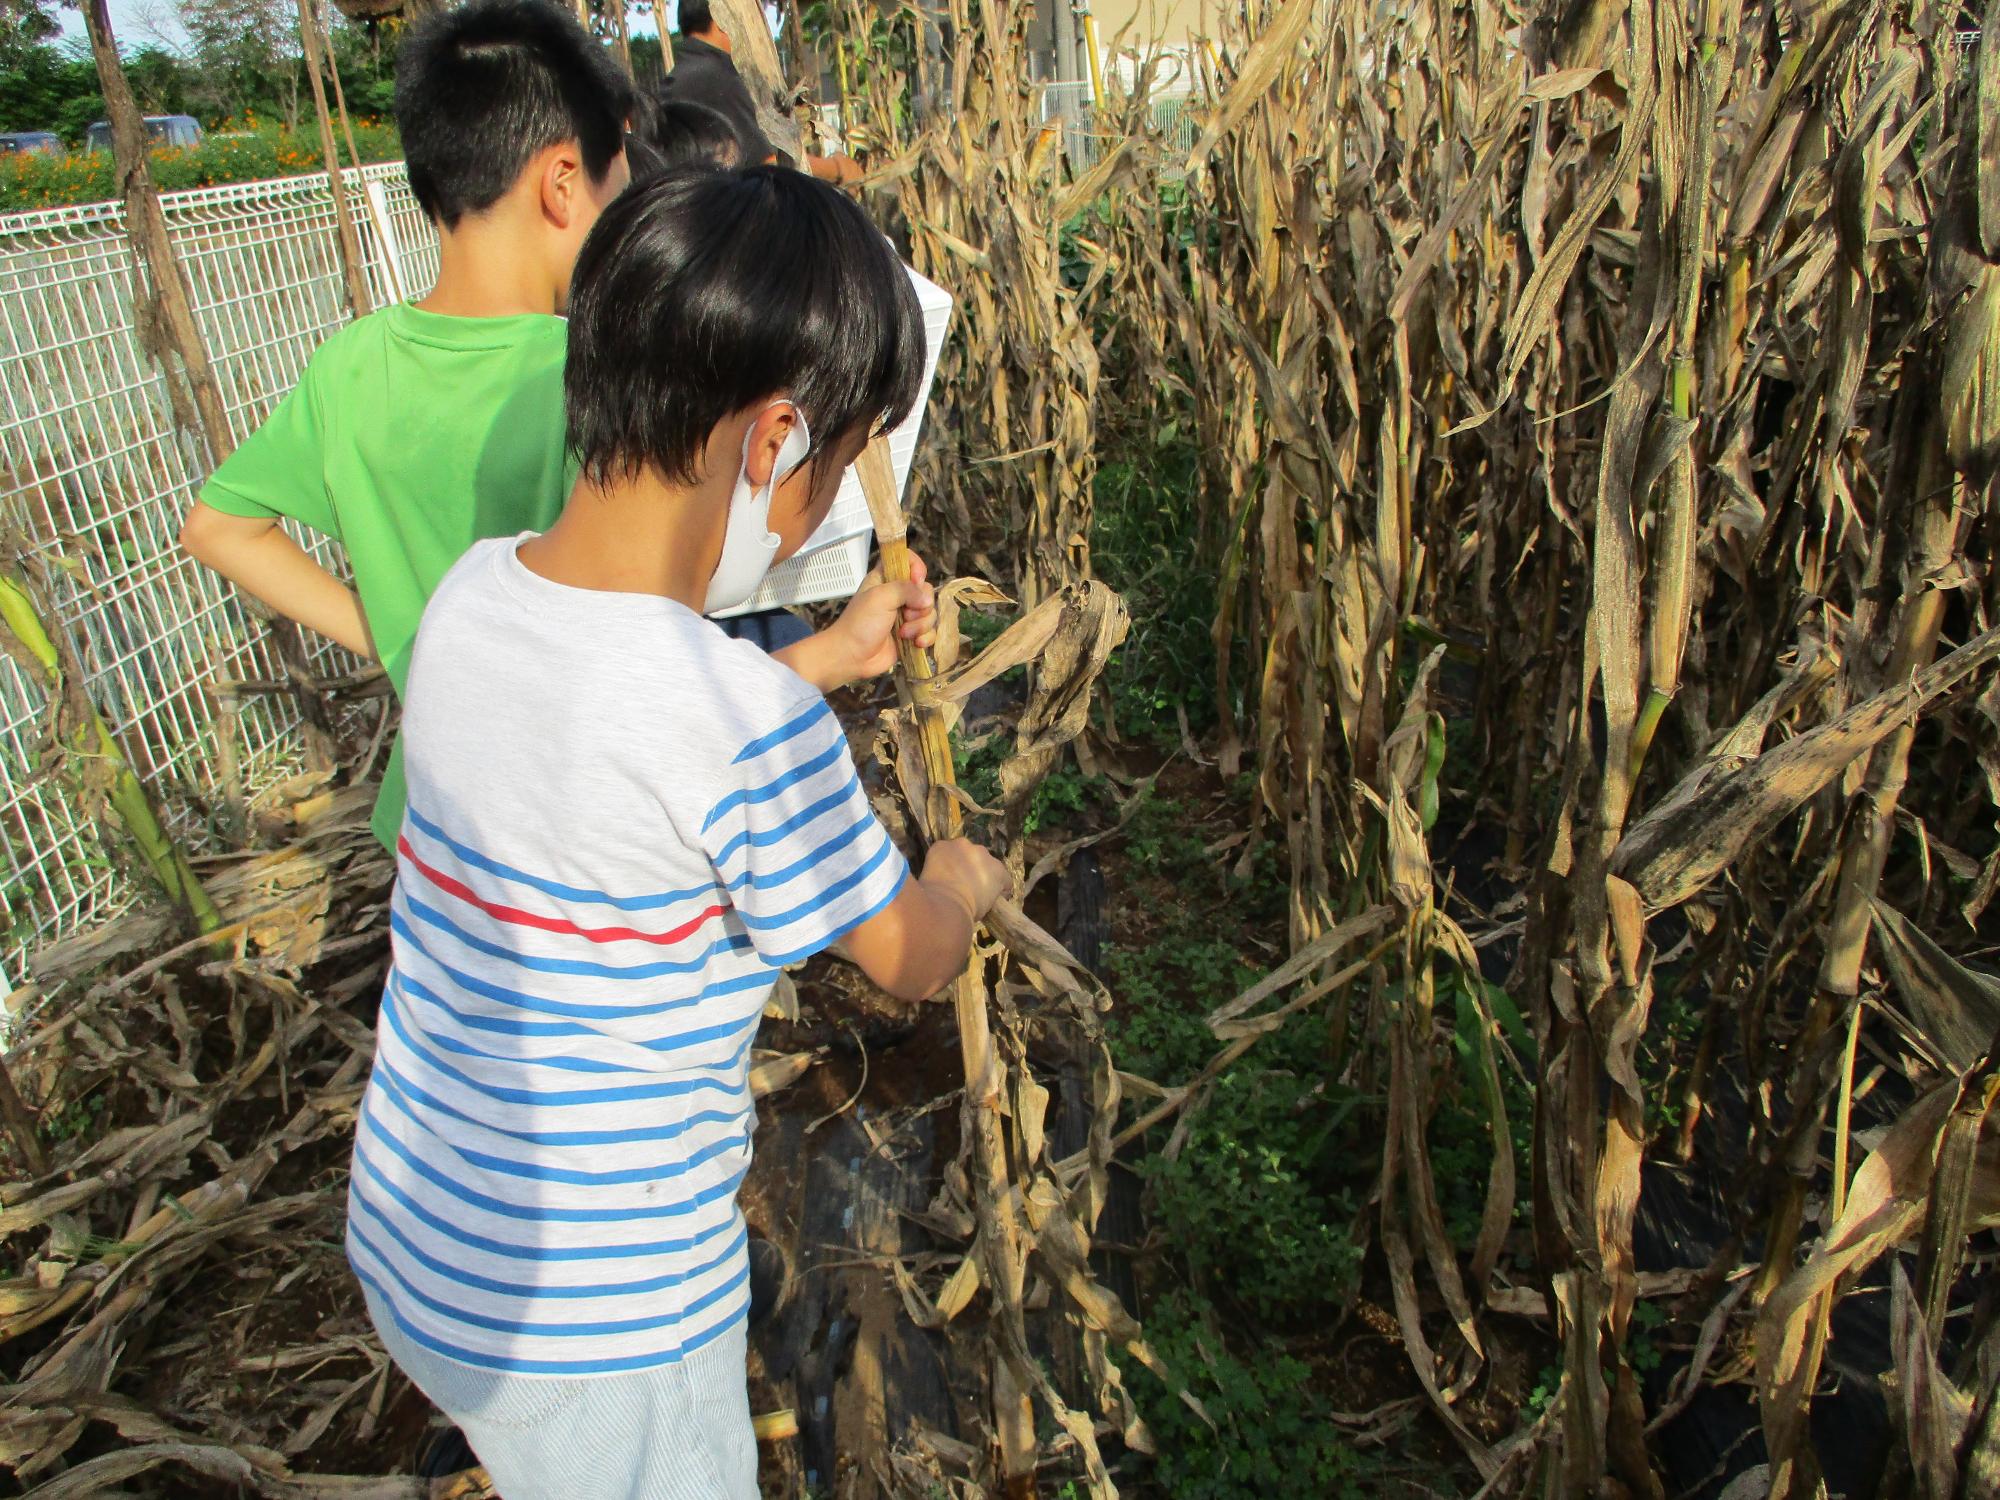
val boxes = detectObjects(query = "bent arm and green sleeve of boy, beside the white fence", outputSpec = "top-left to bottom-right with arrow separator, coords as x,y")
180,364 -> 376,660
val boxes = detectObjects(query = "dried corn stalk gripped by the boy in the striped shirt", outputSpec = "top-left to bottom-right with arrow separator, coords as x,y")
856,440 -> 1160,1500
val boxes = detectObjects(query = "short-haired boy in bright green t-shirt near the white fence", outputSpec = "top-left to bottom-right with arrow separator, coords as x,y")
180,0 -> 632,846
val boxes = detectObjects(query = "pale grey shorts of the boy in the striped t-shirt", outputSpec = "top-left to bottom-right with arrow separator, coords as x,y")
364,1288 -> 758,1500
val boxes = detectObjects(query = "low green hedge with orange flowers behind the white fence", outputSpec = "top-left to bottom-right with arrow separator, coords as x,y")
0,118 -> 402,212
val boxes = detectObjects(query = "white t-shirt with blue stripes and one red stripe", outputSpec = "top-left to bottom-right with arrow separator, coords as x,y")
348,538 -> 908,1376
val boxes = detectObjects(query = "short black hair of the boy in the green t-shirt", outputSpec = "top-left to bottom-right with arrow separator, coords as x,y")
396,0 -> 632,228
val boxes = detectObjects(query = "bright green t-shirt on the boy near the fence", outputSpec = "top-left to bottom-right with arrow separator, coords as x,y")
202,306 -> 576,848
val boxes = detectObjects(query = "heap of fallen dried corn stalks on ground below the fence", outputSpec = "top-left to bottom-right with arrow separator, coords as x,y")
0,786 -> 402,1500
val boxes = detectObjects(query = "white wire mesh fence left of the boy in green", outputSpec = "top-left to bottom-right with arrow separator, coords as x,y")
0,164 -> 438,992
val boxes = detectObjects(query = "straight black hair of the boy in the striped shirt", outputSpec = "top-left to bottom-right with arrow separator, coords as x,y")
562,166 -> 924,484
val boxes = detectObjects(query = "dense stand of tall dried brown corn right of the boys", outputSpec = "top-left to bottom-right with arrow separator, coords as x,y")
828,0 -> 2000,1500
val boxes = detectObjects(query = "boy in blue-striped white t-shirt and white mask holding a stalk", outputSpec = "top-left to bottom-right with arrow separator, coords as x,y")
348,168 -> 1008,1500
